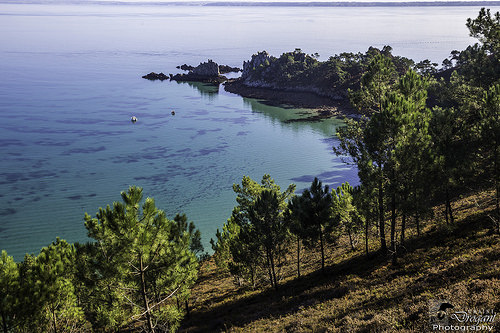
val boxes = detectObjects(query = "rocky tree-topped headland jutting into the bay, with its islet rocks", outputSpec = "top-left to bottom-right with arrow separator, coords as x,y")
143,46 -> 413,120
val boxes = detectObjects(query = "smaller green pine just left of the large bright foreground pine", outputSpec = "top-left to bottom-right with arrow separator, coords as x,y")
11,238 -> 88,332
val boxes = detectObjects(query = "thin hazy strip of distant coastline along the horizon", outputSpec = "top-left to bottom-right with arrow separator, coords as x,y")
0,0 -> 500,7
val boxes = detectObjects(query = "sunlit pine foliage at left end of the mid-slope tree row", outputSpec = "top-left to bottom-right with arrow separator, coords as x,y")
211,175 -> 295,286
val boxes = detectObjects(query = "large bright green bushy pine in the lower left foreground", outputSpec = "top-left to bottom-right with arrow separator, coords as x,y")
85,187 -> 198,332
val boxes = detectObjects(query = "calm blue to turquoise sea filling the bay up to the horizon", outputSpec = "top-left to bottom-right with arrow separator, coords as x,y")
0,2 -> 499,261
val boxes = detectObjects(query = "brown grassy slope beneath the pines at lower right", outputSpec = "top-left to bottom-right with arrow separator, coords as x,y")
181,192 -> 500,332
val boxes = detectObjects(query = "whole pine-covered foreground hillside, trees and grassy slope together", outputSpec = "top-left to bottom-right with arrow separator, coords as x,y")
0,10 -> 500,332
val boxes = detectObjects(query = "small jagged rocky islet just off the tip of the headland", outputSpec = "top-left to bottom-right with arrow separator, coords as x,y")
143,59 -> 240,85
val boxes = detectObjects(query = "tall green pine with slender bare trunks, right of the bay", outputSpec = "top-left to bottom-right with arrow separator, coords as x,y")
334,68 -> 432,251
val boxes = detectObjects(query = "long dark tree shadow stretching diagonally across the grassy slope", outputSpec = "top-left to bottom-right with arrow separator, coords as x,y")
181,212 -> 496,332
